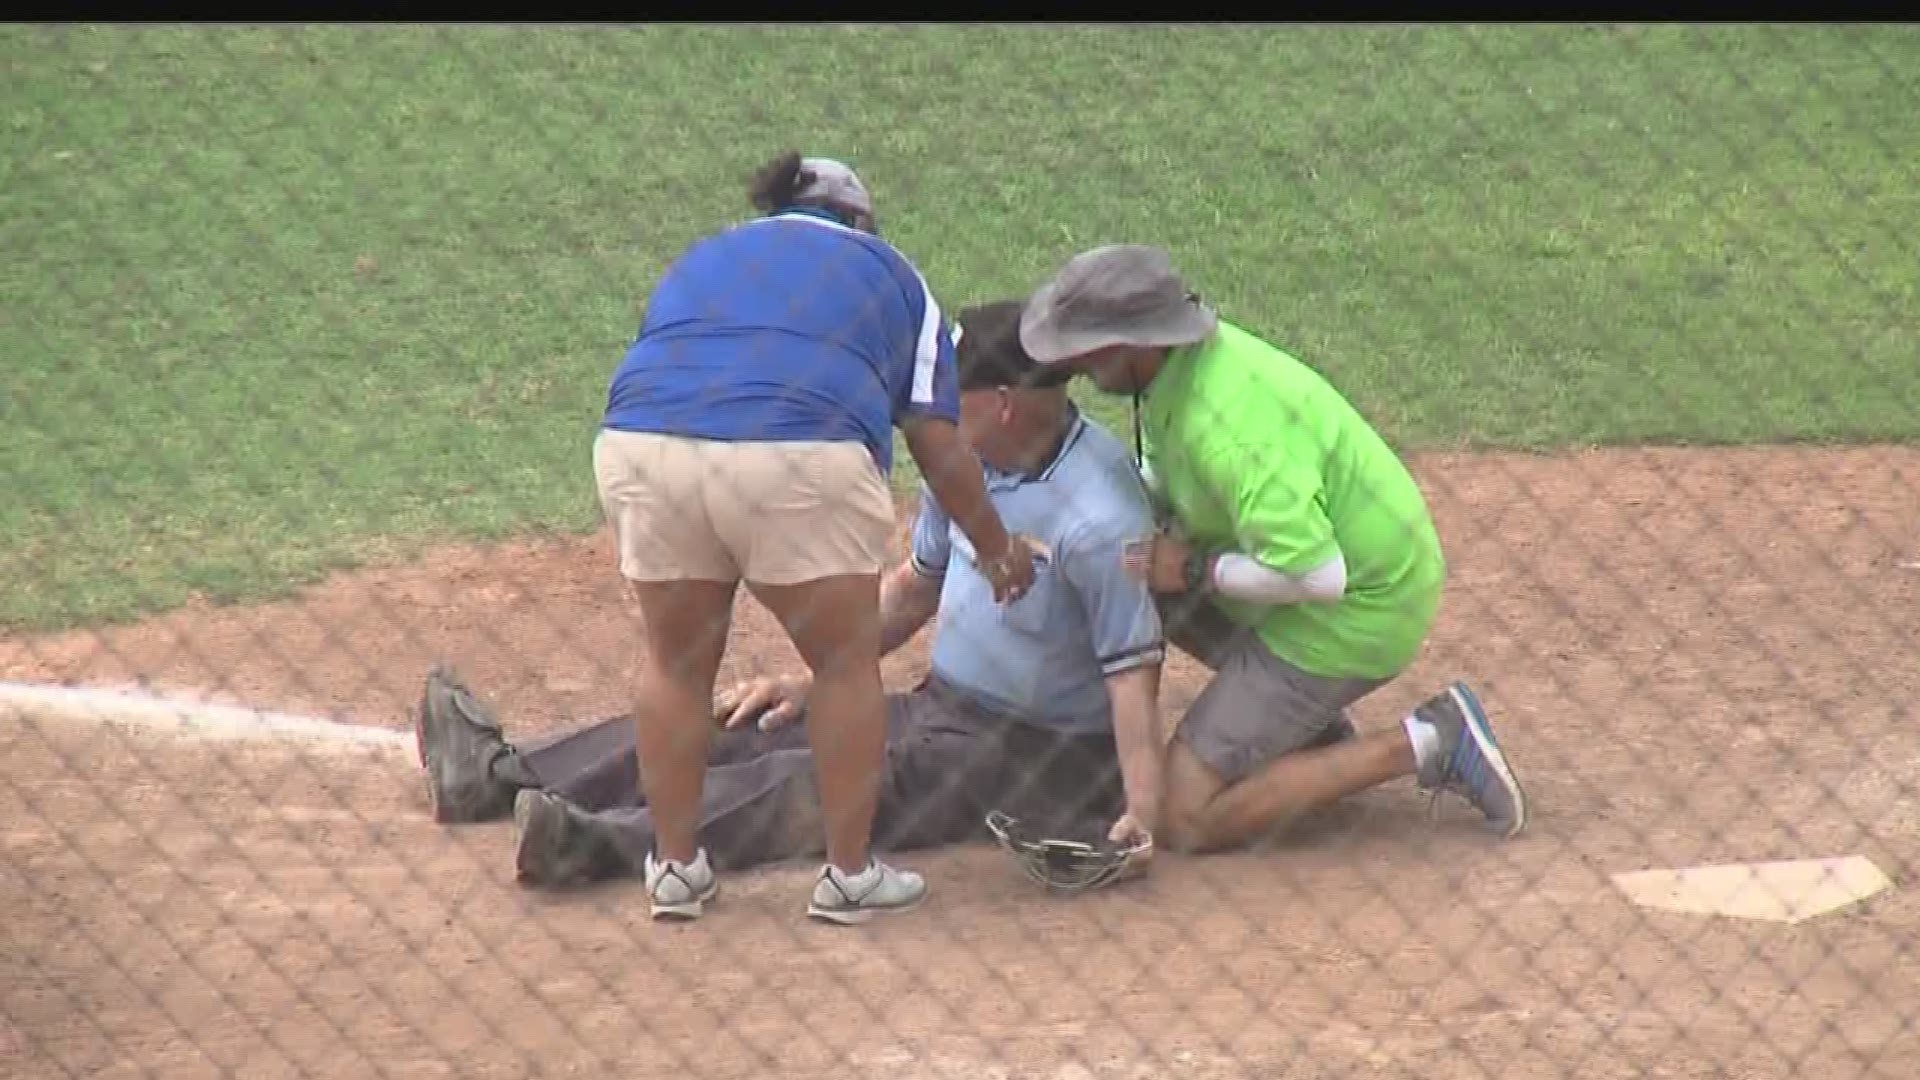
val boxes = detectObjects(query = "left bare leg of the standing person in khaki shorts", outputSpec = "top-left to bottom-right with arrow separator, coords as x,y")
634,580 -> 735,863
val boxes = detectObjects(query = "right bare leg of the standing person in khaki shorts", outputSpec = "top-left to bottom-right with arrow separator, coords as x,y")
749,575 -> 887,874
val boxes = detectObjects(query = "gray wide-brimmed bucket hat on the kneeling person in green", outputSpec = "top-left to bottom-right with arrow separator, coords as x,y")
1020,244 -> 1219,363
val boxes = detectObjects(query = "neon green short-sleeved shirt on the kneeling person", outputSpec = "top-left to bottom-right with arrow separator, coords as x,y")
1140,321 -> 1446,678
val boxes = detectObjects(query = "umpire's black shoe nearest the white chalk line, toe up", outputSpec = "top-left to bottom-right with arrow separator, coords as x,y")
413,665 -> 516,822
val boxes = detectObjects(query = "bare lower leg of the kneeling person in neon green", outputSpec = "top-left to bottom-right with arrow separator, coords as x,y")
1167,730 -> 1413,853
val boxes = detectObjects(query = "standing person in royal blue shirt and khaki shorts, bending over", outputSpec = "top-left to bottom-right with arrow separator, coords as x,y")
593,152 -> 1033,920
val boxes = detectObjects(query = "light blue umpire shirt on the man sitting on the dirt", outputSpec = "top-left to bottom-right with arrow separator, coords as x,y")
912,407 -> 1165,732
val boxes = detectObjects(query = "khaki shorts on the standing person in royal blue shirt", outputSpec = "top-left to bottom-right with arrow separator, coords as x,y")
593,429 -> 893,584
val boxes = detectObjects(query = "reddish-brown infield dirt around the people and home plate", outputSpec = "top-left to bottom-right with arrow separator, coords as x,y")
0,448 -> 1920,1080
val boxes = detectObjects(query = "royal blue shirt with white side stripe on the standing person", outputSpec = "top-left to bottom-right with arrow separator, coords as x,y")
603,209 -> 960,473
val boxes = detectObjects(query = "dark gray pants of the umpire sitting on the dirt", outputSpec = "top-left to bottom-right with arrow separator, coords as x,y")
516,676 -> 1125,876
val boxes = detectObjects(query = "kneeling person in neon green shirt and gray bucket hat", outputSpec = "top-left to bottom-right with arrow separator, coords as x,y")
1020,244 -> 1526,851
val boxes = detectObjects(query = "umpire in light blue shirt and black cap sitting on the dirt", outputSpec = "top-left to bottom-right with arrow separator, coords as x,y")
417,300 -> 1164,920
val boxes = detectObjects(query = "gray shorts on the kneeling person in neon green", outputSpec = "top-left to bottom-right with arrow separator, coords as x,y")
1160,598 -> 1390,784
